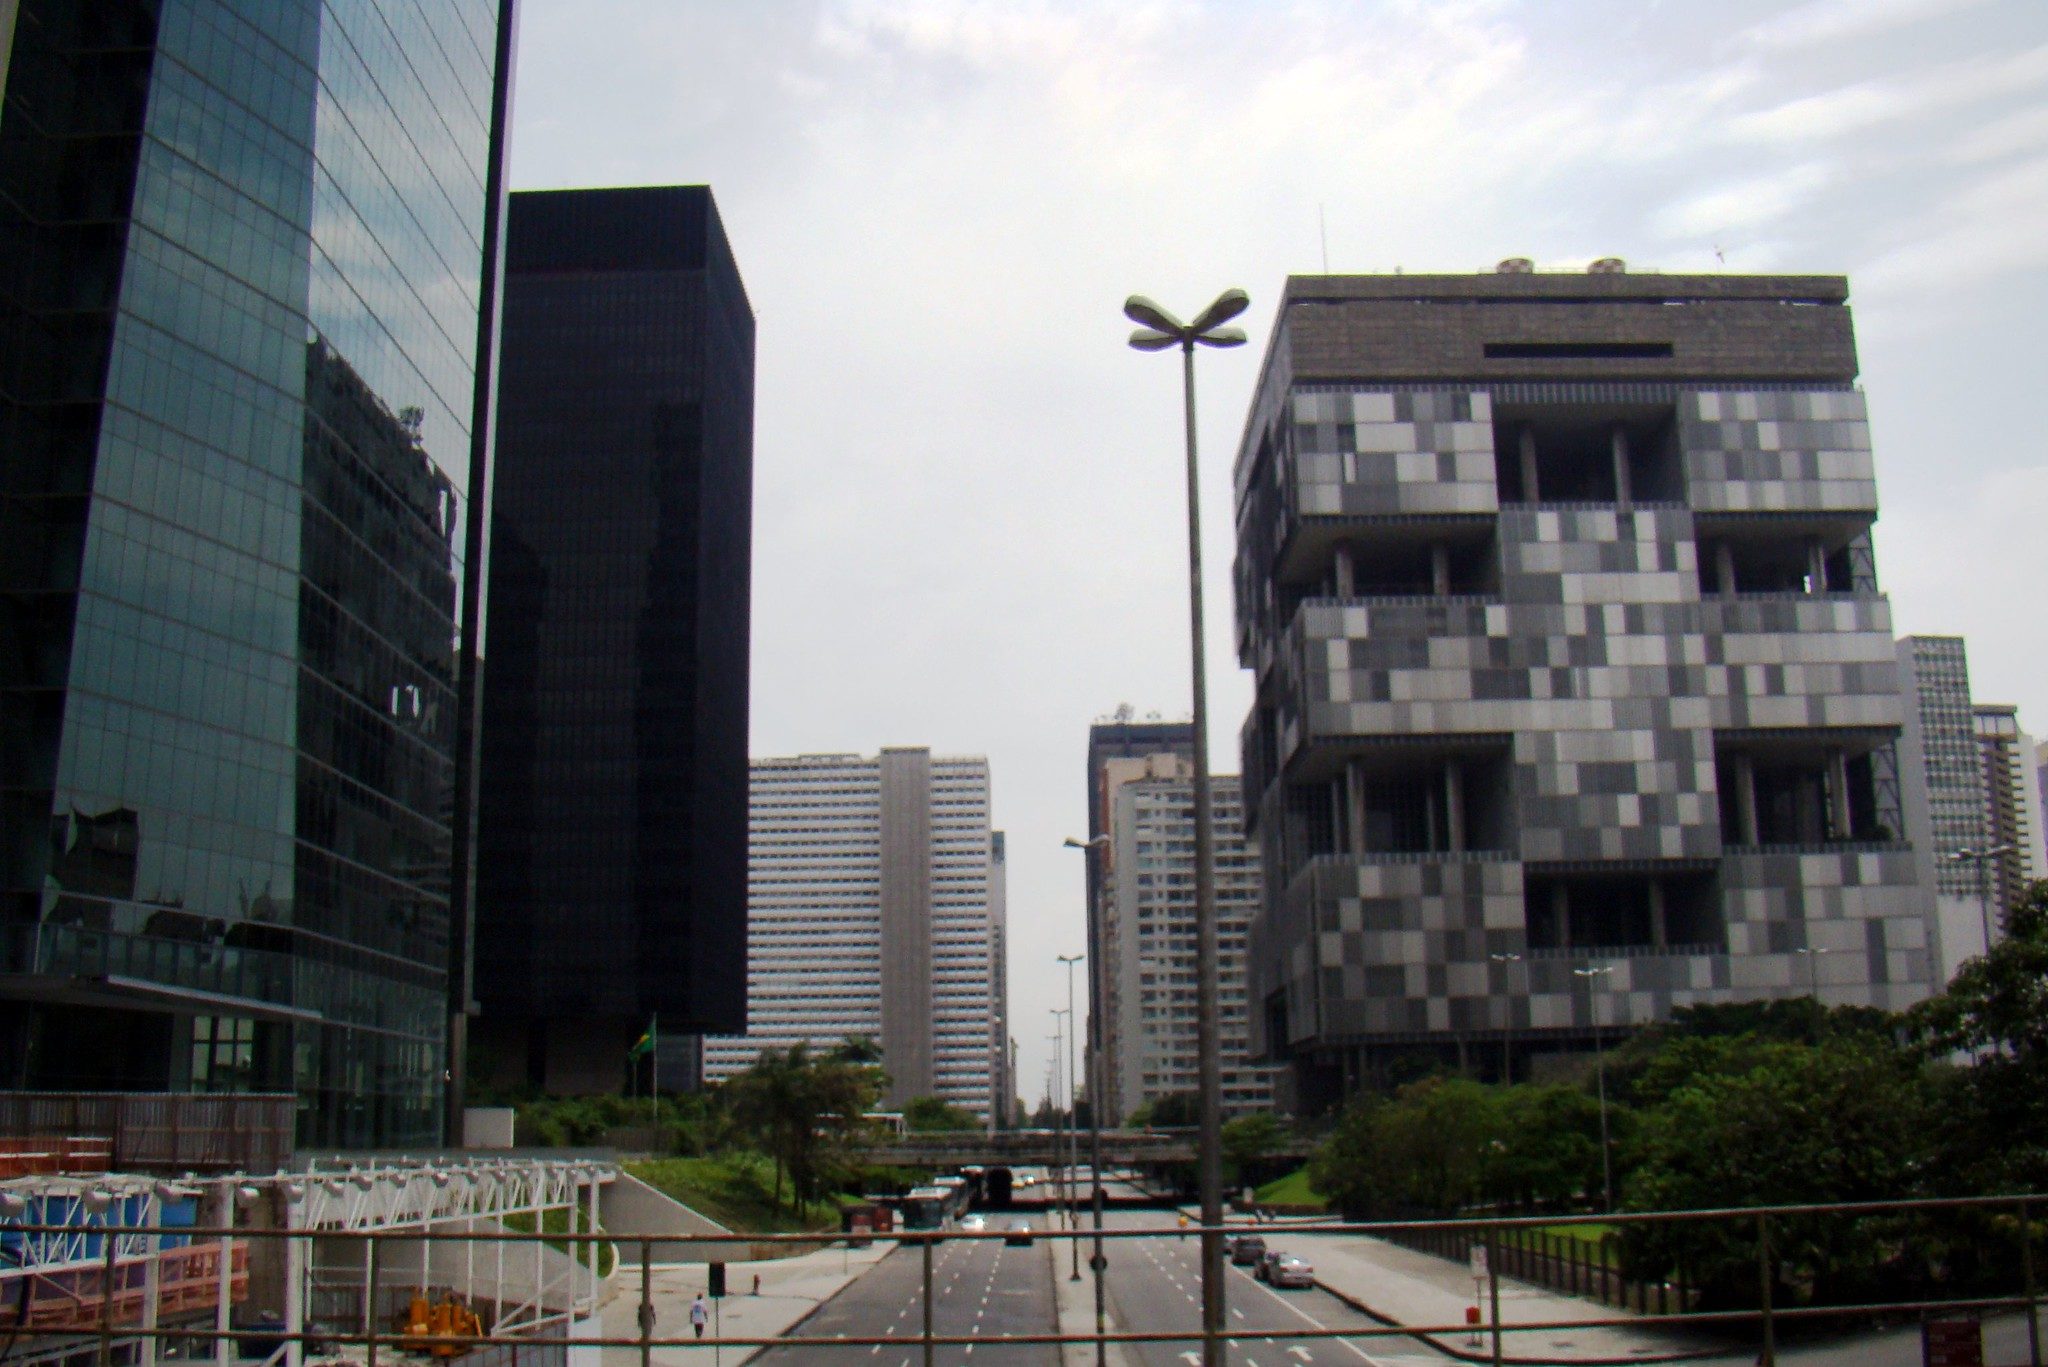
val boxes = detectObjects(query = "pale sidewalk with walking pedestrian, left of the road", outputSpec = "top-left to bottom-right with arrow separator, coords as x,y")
602,1240 -> 895,1367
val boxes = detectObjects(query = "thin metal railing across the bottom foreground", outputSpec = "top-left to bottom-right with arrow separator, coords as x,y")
0,1193 -> 2048,1367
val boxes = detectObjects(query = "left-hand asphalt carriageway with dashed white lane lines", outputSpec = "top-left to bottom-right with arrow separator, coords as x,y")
754,1221 -> 1057,1367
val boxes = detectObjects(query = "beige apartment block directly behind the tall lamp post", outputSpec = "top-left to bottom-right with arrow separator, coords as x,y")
1098,752 -> 1272,1119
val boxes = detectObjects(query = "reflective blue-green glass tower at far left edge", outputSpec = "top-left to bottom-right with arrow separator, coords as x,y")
0,0 -> 512,1146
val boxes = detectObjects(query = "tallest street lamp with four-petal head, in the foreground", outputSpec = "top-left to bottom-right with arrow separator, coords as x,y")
1124,289 -> 1251,1367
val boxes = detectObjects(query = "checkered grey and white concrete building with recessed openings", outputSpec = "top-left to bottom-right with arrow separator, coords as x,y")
1237,271 -> 1929,1109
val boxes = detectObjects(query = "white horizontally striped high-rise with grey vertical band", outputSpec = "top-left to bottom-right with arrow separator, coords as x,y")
705,748 -> 1008,1119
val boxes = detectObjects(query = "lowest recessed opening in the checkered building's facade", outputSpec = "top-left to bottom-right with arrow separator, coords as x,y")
1524,867 -> 1726,953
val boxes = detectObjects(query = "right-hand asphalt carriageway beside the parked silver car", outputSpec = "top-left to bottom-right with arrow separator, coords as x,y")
1104,1211 -> 1450,1367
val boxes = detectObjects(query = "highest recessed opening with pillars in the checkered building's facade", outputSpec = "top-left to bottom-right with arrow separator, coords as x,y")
1493,404 -> 1686,506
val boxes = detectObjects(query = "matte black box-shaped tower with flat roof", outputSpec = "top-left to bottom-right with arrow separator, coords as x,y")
475,187 -> 754,1092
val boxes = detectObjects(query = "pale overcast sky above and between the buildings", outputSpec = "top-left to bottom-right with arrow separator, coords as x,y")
512,0 -> 2048,1101
